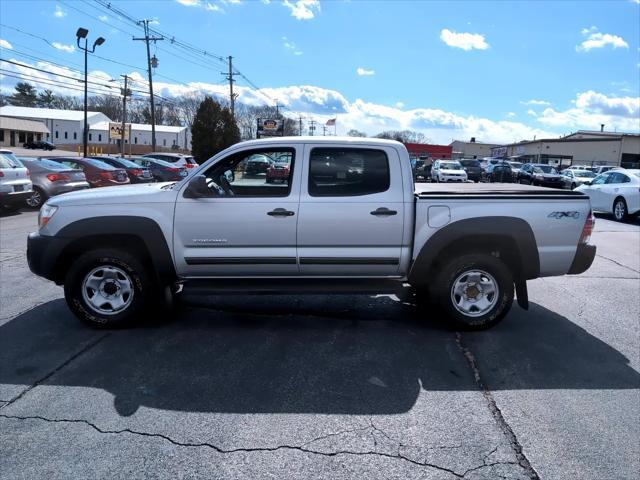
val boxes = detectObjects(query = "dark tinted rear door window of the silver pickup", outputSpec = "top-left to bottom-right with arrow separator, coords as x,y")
309,148 -> 390,197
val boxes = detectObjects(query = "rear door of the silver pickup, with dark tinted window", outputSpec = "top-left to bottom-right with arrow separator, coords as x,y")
298,144 -> 404,276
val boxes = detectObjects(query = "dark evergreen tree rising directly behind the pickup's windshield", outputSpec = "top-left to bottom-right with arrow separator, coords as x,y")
191,96 -> 240,163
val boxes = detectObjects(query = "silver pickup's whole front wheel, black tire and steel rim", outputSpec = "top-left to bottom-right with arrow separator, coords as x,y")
64,249 -> 158,328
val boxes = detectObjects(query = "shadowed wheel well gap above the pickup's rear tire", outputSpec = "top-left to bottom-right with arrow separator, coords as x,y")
427,235 -> 523,280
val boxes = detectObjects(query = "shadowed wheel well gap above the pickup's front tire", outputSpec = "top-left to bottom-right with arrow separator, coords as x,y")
55,234 -> 155,284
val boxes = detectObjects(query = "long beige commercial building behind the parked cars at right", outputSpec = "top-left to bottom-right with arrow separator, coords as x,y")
491,130 -> 640,168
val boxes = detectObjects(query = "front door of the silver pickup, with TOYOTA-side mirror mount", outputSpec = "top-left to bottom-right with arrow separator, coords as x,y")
173,145 -> 303,277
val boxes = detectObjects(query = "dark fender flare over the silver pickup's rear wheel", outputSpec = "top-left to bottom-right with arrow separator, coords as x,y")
408,216 -> 540,285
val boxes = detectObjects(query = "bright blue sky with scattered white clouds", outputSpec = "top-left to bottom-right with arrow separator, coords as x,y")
0,0 -> 640,143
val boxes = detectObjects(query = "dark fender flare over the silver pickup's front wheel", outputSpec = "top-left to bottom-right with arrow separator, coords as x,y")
56,215 -> 177,281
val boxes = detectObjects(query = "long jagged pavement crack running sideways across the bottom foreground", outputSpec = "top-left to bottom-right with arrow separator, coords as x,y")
0,414 -> 521,478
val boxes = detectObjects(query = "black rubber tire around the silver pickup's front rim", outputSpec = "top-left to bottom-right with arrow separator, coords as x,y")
64,249 -> 162,329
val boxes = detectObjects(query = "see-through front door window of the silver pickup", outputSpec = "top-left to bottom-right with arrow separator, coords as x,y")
198,148 -> 295,197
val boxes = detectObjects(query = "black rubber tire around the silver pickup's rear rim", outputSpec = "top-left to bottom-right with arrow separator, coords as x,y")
433,254 -> 514,330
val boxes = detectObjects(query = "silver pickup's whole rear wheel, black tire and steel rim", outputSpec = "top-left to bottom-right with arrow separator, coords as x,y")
434,254 -> 514,330
